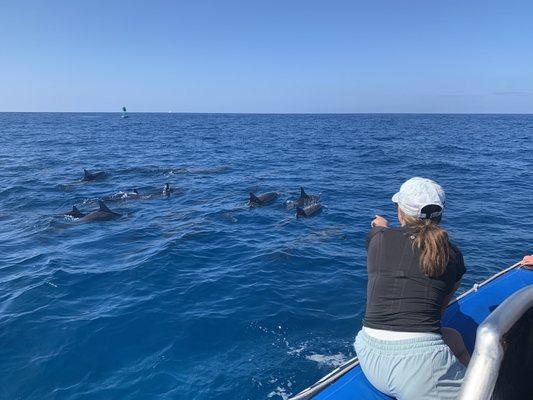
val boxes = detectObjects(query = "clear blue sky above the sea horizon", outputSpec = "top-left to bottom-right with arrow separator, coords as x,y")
0,0 -> 533,113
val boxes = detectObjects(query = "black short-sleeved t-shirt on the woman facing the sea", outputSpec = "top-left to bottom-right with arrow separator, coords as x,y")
363,227 -> 466,332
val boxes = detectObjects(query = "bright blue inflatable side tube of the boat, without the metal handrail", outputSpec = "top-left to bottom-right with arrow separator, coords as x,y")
291,263 -> 533,400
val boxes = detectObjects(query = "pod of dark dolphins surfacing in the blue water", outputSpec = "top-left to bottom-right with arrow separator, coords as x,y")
64,169 -> 323,222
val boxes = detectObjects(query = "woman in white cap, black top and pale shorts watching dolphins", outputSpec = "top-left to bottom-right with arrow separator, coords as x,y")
355,178 -> 470,400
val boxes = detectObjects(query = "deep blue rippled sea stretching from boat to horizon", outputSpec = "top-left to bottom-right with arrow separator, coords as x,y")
0,113 -> 533,400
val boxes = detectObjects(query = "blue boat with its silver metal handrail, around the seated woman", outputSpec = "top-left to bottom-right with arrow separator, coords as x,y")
291,263 -> 533,400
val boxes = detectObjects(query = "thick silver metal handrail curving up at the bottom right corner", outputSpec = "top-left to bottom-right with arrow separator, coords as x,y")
458,285 -> 533,400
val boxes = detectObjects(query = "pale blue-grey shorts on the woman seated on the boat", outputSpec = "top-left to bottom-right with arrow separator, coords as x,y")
355,330 -> 466,400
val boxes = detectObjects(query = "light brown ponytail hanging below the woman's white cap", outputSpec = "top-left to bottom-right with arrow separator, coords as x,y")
400,210 -> 450,278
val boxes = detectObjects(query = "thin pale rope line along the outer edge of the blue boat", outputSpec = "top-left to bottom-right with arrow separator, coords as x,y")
289,261 -> 522,400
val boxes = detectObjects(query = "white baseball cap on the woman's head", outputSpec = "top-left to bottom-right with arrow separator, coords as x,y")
392,177 -> 446,218
